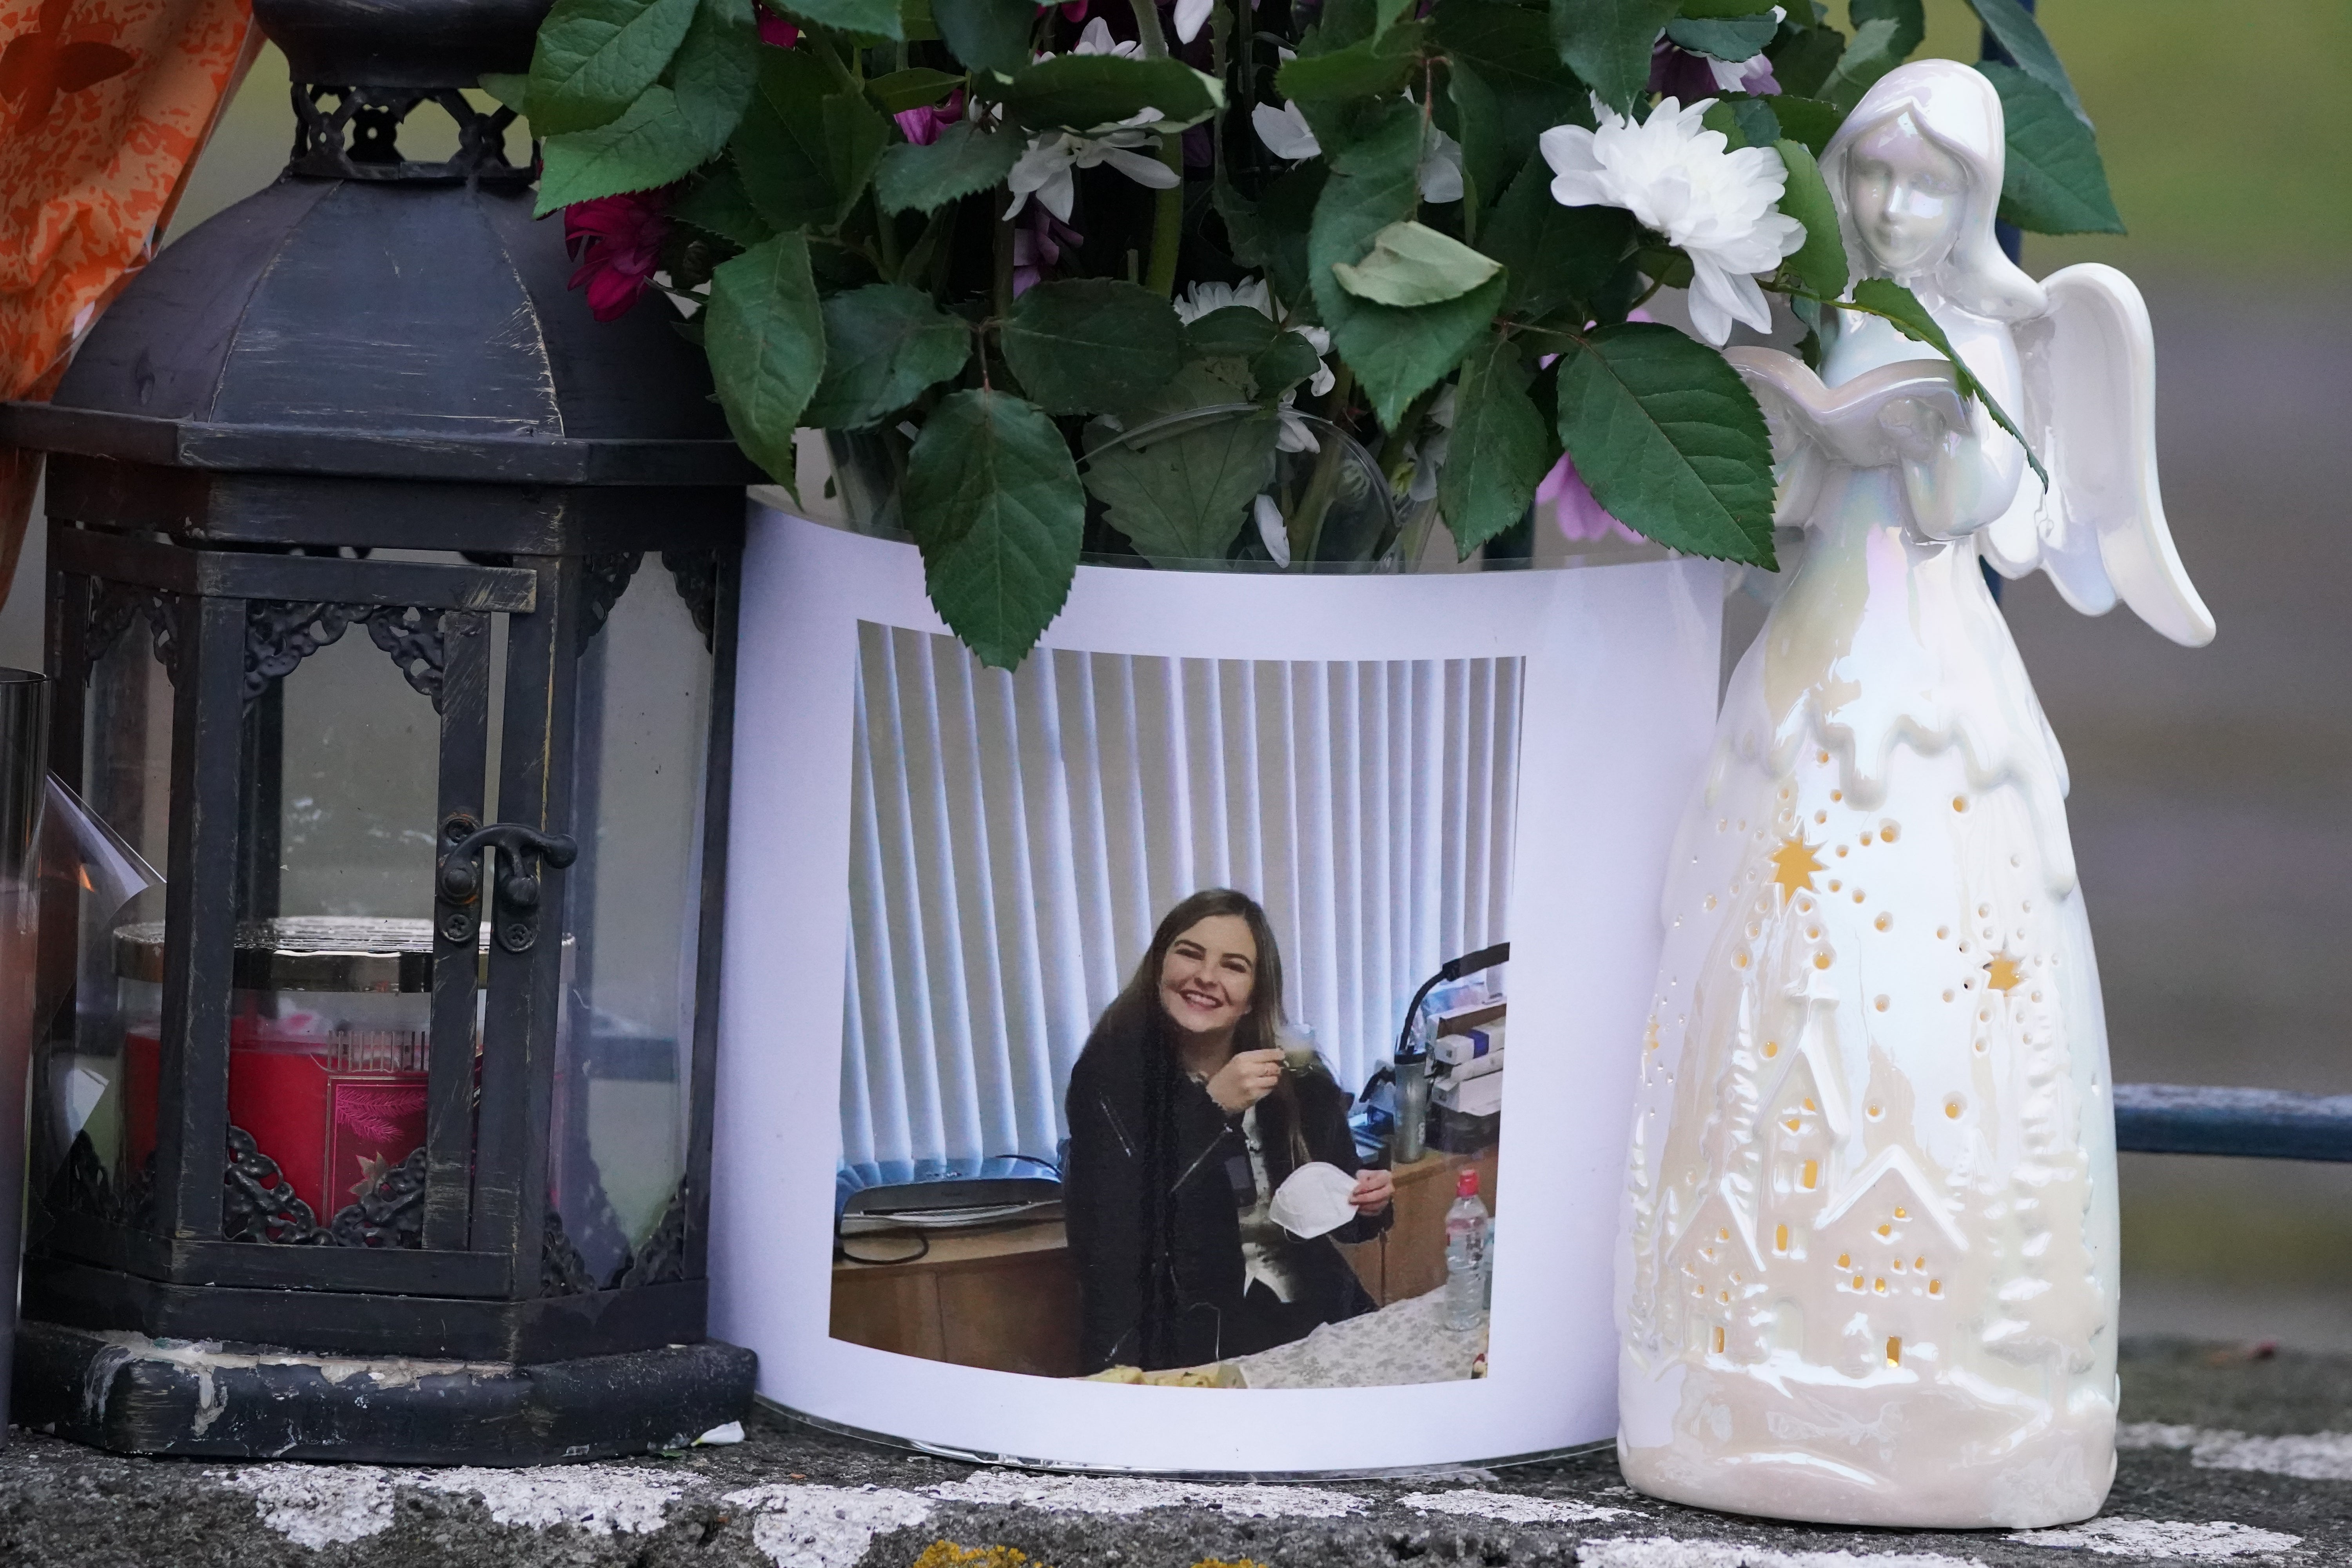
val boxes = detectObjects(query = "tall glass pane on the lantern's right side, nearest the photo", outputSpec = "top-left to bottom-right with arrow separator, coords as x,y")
548,571 -> 713,1283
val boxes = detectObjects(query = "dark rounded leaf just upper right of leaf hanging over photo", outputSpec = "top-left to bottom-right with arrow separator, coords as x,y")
1000,278 -> 1183,414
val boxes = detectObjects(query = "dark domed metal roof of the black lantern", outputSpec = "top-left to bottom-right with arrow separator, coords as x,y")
40,172 -> 755,484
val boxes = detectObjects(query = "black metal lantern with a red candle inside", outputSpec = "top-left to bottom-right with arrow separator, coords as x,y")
0,0 -> 757,1462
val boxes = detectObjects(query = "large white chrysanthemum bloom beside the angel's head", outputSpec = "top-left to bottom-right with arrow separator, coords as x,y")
1538,99 -> 1804,346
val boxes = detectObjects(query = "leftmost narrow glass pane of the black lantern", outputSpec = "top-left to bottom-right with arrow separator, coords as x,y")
38,613 -> 172,1208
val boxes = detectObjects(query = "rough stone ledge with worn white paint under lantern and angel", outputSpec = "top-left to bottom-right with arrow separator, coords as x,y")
0,1340 -> 2352,1568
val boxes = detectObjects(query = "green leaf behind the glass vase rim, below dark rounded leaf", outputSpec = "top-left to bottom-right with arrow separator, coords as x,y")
1087,409 -> 1279,566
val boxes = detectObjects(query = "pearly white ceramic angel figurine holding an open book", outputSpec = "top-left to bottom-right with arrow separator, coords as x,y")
1618,61 -> 2213,1528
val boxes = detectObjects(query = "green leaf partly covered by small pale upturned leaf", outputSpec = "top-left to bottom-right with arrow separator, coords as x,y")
1308,101 -> 1508,425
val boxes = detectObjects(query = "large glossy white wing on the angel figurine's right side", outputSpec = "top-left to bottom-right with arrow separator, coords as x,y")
1978,261 -> 2213,649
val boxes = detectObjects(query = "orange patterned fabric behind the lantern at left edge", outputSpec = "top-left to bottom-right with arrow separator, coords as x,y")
0,0 -> 261,595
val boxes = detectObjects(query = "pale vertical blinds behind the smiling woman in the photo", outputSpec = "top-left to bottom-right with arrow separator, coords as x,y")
842,623 -> 1522,1166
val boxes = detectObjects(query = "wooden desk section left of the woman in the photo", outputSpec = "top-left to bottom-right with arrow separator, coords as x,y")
833,1220 -> 1080,1377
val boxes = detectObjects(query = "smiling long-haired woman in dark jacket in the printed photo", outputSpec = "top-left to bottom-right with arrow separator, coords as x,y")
1063,889 -> 1390,1373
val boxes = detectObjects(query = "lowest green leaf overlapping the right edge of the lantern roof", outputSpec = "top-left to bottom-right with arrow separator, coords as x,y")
703,235 -> 826,489
